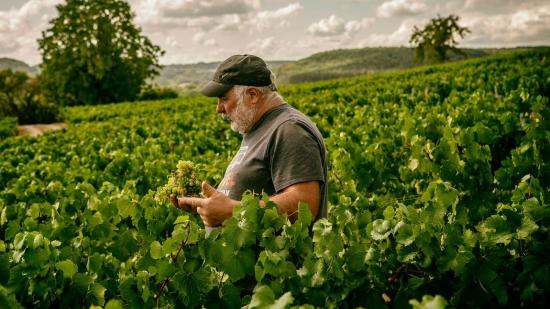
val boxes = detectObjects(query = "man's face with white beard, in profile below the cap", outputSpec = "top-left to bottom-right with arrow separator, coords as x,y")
216,87 -> 256,134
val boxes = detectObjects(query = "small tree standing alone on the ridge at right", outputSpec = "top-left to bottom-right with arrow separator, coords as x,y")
409,15 -> 470,63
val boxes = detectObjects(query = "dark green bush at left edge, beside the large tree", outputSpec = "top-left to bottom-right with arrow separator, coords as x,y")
0,69 -> 62,124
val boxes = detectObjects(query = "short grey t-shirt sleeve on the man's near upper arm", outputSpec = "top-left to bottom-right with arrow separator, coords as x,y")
268,120 -> 325,192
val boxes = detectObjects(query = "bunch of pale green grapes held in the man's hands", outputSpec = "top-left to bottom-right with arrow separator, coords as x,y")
155,160 -> 201,203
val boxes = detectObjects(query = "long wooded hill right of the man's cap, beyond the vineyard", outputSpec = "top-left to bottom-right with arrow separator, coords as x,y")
276,47 -> 532,84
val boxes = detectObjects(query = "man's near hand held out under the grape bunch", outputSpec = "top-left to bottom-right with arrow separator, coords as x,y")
170,181 -> 239,226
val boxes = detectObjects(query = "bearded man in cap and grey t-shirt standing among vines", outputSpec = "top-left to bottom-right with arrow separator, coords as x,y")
172,55 -> 327,230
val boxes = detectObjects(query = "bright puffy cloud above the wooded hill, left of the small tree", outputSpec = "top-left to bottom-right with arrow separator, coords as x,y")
307,15 -> 374,37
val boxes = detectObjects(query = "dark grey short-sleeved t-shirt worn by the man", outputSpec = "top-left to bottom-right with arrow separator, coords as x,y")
218,104 -> 327,219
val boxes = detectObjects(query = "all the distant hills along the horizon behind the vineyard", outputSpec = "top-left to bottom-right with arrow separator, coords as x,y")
0,47 -> 532,93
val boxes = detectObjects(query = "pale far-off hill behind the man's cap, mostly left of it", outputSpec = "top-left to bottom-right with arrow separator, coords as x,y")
153,61 -> 291,92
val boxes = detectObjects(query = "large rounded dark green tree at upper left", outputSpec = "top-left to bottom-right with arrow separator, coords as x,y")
38,0 -> 164,105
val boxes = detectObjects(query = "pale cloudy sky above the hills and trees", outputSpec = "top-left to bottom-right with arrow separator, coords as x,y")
0,0 -> 550,65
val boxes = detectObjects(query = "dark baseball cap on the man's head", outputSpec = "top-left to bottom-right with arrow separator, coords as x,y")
201,55 -> 277,97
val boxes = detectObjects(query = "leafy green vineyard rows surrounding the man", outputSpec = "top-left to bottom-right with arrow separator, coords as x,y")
0,48 -> 550,308
